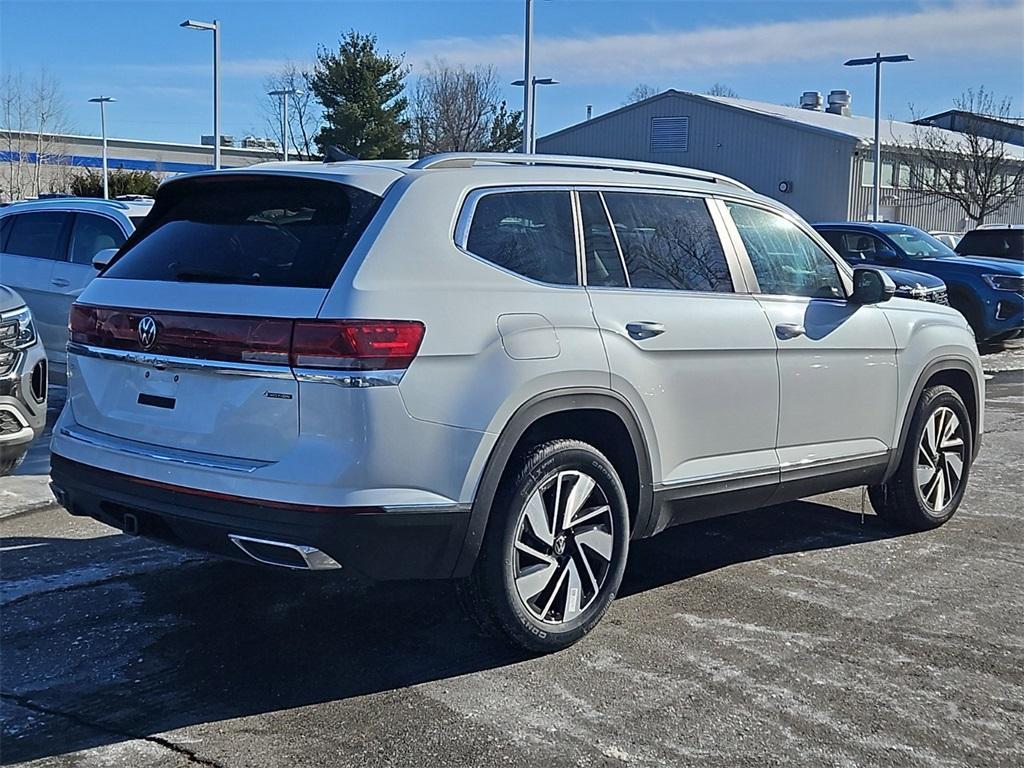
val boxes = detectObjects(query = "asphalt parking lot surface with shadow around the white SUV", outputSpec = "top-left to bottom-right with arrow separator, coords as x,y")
0,358 -> 1024,767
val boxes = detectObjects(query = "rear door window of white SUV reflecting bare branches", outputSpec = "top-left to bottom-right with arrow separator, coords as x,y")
604,193 -> 733,293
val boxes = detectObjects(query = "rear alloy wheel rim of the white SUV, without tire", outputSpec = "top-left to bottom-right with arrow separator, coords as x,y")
512,470 -> 614,625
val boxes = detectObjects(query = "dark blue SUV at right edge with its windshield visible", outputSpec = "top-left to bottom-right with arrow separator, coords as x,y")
814,221 -> 1024,342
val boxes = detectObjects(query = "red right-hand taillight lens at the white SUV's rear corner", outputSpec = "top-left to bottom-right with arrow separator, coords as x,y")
292,321 -> 426,371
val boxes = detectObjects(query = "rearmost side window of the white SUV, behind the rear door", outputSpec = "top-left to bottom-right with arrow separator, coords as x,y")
466,189 -> 578,286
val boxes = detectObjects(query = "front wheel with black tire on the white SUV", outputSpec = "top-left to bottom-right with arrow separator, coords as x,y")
867,385 -> 974,530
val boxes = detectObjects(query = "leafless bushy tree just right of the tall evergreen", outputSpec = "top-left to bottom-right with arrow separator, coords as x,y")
410,59 -> 522,157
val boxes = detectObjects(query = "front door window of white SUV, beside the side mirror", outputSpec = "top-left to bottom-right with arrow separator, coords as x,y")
726,203 -> 845,299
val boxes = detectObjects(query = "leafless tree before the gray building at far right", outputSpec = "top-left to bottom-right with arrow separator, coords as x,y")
896,86 -> 1024,224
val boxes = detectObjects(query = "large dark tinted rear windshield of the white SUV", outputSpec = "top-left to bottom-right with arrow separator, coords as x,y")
103,175 -> 380,288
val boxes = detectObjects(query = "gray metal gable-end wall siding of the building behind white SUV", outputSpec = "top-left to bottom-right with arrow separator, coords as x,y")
538,93 -> 854,221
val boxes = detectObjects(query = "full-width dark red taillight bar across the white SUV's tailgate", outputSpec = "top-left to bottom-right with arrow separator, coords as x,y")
70,304 -> 425,371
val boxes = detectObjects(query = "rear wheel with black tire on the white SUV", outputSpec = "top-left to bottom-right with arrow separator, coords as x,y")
459,440 -> 630,653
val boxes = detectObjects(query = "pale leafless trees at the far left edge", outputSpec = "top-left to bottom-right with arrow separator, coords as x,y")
0,70 -> 71,200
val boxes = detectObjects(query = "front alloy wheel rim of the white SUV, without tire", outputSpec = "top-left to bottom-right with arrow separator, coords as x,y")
918,407 -> 966,514
